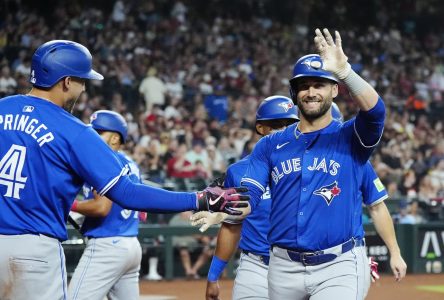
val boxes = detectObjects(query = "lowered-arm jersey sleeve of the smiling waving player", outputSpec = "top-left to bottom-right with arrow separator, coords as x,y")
241,137 -> 271,210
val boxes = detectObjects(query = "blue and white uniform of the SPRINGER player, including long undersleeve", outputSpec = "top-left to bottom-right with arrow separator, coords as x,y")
0,95 -> 197,299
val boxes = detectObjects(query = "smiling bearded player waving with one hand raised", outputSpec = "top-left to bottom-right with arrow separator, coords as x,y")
242,29 -> 406,300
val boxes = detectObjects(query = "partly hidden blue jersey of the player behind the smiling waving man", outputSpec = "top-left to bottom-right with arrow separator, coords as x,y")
224,156 -> 271,256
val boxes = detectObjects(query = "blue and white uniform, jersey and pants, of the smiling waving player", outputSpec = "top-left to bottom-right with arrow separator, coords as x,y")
242,100 -> 384,299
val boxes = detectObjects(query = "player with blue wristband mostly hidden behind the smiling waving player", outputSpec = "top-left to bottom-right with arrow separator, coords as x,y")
206,95 -> 299,299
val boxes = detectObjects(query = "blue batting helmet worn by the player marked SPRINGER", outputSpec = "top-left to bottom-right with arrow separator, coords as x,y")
29,40 -> 103,88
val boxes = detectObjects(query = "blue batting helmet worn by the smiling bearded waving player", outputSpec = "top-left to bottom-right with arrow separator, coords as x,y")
290,54 -> 338,99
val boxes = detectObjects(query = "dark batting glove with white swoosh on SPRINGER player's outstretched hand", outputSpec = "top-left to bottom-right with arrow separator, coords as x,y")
197,186 -> 250,215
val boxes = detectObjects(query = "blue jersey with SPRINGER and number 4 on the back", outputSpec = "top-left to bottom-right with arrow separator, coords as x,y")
0,95 -> 127,240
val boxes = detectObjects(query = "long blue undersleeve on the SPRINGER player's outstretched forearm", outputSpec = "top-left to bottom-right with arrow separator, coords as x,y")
106,176 -> 197,213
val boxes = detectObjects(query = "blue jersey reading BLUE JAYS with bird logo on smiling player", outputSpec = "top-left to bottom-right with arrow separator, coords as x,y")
242,115 -> 384,251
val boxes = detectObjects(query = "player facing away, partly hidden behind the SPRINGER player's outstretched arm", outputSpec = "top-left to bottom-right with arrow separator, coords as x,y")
68,110 -> 143,300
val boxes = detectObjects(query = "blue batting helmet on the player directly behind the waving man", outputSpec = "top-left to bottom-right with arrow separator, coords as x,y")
256,95 -> 299,121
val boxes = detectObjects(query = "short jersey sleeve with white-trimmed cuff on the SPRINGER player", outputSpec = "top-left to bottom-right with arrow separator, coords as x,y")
70,127 -> 128,195
